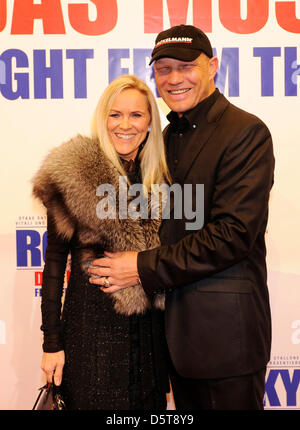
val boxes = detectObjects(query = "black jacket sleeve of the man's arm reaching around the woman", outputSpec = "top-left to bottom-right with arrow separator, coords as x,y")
138,121 -> 274,295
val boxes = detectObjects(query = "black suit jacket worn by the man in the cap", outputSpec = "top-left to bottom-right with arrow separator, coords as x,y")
138,90 -> 274,378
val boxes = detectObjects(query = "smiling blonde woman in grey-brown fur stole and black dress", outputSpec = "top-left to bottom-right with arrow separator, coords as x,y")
33,76 -> 169,410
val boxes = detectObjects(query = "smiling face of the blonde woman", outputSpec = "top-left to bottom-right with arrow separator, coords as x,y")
107,88 -> 151,160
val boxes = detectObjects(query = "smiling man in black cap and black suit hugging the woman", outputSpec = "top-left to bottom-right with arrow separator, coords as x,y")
91,25 -> 274,410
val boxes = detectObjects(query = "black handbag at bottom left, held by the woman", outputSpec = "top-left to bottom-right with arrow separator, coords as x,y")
32,383 -> 67,411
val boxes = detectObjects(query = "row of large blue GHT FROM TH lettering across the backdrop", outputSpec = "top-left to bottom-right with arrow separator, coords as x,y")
0,47 -> 300,100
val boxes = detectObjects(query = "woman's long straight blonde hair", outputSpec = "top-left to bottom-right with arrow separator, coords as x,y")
91,75 -> 170,191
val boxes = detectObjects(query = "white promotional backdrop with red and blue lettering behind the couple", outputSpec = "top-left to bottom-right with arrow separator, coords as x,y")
0,0 -> 300,410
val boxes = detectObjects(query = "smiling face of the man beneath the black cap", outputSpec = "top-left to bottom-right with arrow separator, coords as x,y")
154,54 -> 218,116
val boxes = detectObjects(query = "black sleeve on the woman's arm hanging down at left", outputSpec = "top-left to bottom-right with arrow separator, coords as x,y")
41,211 -> 69,352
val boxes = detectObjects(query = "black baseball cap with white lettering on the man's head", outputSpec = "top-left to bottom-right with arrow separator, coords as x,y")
150,25 -> 213,64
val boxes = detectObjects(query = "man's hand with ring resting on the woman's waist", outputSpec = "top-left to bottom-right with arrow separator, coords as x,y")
89,251 -> 139,293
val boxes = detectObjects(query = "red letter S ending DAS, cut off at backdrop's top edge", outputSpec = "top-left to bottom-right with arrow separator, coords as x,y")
69,0 -> 118,36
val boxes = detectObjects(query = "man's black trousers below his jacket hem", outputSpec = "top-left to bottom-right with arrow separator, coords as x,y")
170,365 -> 266,410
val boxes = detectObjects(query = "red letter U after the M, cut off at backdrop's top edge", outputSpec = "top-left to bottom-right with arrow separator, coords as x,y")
219,0 -> 269,34
